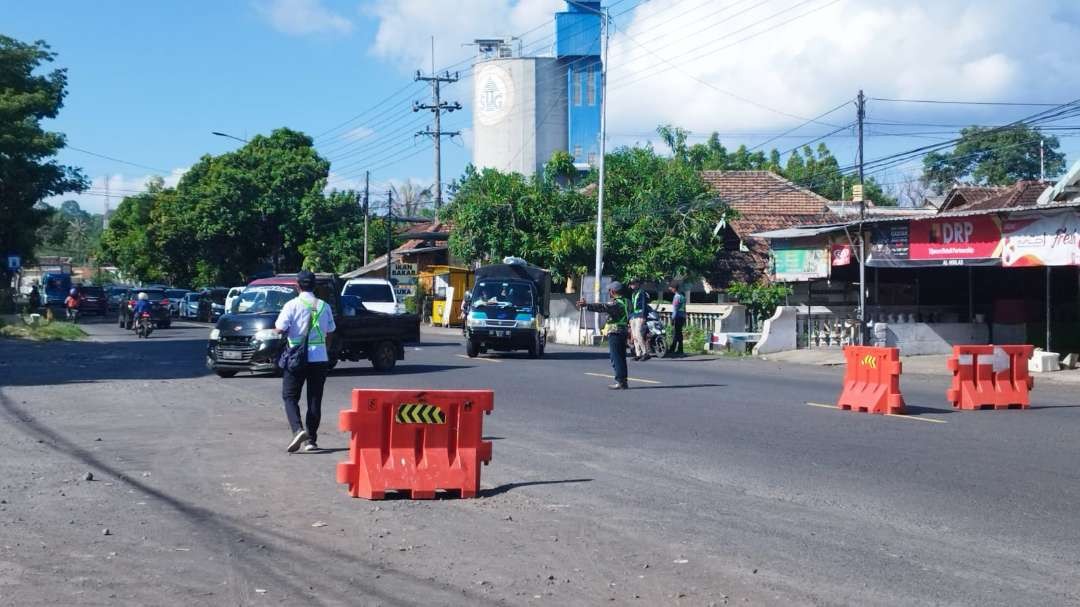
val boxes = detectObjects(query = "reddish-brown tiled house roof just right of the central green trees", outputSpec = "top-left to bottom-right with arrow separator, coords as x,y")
701,171 -> 840,288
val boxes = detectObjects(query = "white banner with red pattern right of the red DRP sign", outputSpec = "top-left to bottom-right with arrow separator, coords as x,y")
1001,211 -> 1080,268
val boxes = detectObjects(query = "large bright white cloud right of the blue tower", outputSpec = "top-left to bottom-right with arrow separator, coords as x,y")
608,0 -> 1080,133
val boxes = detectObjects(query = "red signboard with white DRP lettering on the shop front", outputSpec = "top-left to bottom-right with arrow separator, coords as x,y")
909,215 -> 1001,261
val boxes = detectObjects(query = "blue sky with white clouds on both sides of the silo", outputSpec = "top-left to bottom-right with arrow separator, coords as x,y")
8,0 -> 1080,211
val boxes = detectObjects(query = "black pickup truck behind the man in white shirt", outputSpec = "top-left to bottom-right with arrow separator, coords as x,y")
206,274 -> 420,377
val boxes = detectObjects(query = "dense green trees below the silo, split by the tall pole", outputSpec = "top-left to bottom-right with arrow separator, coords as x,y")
447,147 -> 727,287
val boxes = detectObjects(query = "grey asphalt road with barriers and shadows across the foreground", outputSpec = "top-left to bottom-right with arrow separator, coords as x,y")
0,323 -> 1080,606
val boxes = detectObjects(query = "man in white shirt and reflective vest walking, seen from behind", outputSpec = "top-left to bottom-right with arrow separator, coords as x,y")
274,270 -> 337,453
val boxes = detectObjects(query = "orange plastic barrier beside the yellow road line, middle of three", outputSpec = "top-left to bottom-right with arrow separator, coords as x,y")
836,346 -> 904,414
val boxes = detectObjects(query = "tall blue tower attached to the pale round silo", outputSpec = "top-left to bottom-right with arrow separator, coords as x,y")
555,1 -> 603,170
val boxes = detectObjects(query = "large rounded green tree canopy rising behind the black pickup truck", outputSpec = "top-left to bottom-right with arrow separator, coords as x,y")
103,129 -> 395,286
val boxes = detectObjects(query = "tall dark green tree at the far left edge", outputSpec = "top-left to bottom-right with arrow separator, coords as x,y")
0,36 -> 86,301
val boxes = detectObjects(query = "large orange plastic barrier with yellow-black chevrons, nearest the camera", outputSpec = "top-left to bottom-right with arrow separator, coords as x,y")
337,389 -> 495,499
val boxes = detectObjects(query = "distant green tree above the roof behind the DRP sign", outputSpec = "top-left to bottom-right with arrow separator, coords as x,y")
922,124 -> 1065,194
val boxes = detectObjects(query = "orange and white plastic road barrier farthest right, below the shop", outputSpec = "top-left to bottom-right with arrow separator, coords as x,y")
945,346 -> 1035,409
